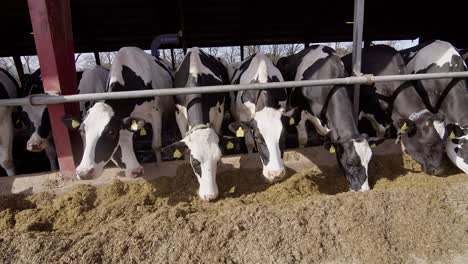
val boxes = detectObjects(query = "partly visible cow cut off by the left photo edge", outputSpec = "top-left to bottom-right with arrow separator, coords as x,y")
0,69 -> 18,176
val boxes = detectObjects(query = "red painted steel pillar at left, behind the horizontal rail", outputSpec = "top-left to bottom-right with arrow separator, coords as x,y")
28,0 -> 79,178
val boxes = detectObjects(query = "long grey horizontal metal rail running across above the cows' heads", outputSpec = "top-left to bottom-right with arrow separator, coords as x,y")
0,71 -> 468,106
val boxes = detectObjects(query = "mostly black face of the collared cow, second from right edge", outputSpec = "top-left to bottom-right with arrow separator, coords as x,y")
397,113 -> 445,175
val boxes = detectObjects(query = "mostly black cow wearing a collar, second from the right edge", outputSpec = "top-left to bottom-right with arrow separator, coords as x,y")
342,45 -> 445,175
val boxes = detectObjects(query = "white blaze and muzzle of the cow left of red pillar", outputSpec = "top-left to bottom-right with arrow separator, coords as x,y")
23,105 -> 50,151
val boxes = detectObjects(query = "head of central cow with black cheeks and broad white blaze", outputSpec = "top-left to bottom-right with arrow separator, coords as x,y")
229,107 -> 298,182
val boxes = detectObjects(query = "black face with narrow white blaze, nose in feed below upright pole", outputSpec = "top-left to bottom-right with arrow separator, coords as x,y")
324,134 -> 384,192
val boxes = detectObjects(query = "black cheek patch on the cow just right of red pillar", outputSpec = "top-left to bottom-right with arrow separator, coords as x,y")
94,117 -> 122,163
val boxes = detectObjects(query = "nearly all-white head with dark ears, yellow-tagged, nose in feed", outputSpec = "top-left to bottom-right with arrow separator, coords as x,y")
162,125 -> 236,201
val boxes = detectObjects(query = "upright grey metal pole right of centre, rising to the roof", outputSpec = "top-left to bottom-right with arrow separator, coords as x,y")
353,0 -> 364,120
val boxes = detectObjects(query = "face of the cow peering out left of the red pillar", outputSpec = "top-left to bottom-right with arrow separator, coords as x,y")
20,105 -> 51,152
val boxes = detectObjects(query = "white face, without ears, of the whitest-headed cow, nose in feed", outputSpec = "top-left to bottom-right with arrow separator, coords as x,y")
182,128 -> 222,201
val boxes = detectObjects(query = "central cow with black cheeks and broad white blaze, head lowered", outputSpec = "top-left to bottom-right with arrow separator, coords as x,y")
229,53 -> 295,182
